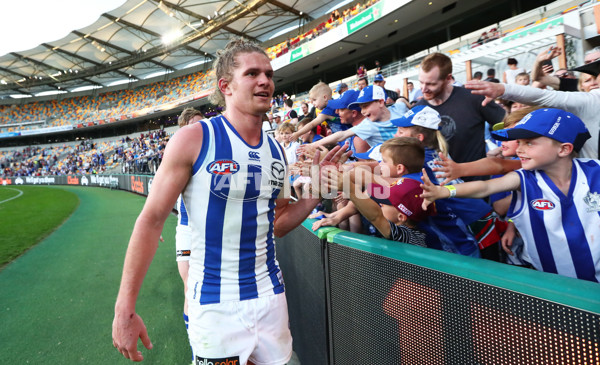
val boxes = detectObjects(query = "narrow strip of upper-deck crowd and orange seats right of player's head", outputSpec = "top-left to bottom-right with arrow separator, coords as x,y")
266,0 -> 379,60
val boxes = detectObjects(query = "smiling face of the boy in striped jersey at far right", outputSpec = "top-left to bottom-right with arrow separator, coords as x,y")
517,137 -> 561,170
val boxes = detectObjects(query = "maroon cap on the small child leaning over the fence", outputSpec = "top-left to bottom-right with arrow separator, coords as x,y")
367,178 -> 436,222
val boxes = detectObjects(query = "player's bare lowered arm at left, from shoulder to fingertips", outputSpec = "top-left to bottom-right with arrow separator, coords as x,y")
113,124 -> 202,361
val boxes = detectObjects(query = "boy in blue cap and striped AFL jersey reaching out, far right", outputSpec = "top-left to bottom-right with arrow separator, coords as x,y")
422,108 -> 600,282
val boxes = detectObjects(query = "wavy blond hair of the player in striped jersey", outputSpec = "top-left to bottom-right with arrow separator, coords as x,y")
209,37 -> 269,106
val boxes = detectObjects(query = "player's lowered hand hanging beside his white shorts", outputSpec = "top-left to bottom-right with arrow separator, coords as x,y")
112,313 -> 152,361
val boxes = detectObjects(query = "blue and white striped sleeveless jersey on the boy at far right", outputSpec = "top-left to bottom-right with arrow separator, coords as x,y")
508,159 -> 600,282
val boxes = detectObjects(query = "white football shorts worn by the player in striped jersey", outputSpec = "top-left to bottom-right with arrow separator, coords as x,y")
188,292 -> 292,365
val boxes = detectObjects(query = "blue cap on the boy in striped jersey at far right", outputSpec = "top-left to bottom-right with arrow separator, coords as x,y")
492,108 -> 591,152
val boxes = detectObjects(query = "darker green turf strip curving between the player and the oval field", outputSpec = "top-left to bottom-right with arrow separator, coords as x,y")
0,187 -> 191,365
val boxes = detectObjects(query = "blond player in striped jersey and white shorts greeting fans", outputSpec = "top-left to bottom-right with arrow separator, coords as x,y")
113,39 -> 328,365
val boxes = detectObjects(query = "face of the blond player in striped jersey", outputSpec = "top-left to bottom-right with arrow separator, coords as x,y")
224,52 -> 275,115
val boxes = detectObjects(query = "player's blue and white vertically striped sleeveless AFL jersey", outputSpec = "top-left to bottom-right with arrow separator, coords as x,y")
183,116 -> 287,304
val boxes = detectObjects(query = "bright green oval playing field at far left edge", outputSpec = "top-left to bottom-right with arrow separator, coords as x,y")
0,186 -> 79,268
